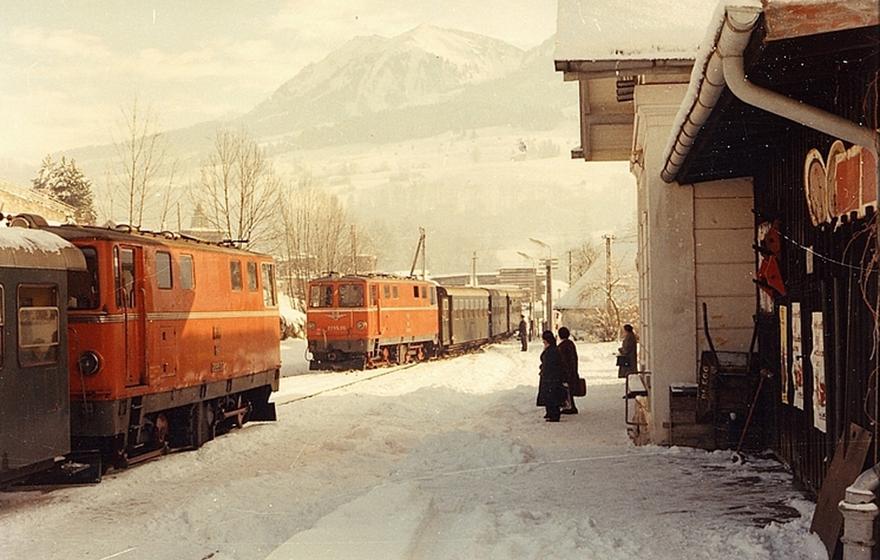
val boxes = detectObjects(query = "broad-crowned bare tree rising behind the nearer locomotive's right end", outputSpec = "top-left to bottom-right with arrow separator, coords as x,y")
193,130 -> 280,252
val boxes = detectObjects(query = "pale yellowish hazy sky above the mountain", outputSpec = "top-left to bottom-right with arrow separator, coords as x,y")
0,0 -> 556,161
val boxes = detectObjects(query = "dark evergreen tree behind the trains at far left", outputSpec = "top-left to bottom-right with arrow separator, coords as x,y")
32,156 -> 97,224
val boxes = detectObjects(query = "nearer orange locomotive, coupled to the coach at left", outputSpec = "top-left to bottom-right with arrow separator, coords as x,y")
44,226 -> 281,464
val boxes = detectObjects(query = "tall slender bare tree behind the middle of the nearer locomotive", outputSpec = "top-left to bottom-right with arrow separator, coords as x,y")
116,98 -> 166,227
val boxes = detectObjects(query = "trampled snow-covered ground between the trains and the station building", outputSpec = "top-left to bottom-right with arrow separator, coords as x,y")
0,343 -> 826,560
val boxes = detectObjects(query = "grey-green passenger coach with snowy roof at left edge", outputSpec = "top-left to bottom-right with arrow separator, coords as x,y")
0,227 -> 86,486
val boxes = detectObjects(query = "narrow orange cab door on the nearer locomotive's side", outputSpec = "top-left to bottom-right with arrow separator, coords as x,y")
113,245 -> 147,387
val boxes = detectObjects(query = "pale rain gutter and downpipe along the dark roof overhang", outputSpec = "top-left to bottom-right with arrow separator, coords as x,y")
660,5 -> 880,183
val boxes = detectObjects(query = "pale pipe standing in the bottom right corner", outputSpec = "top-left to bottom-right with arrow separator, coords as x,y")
837,463 -> 880,560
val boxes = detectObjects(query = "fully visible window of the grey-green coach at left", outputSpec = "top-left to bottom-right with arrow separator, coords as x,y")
18,284 -> 59,367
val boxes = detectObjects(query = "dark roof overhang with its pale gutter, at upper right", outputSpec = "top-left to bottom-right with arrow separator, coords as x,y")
661,0 -> 880,183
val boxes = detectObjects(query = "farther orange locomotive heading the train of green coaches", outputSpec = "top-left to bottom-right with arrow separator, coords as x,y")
306,274 -> 439,369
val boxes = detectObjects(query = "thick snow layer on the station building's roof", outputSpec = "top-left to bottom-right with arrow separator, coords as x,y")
555,0 -> 715,60
